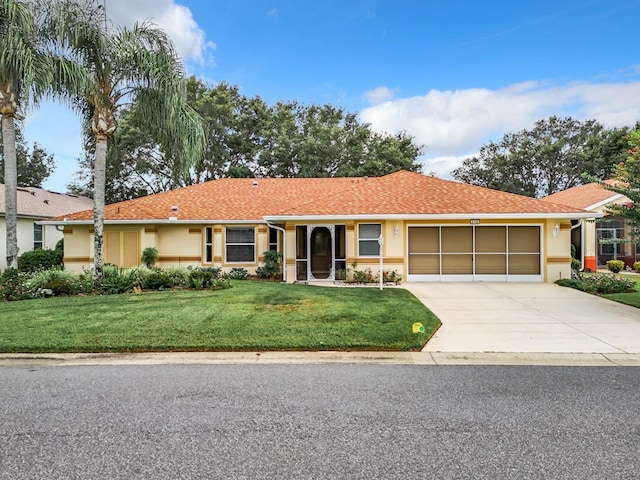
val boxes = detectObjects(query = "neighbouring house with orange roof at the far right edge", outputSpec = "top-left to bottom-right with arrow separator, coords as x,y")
542,183 -> 640,272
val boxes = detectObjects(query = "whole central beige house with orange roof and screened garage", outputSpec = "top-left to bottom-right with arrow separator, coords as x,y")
46,171 -> 594,282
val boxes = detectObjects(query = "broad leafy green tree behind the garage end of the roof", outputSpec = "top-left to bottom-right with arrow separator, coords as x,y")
452,117 -> 628,197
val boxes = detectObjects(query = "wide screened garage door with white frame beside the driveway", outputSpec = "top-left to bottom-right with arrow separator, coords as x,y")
407,225 -> 542,282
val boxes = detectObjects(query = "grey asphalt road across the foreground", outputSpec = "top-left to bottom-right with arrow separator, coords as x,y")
0,365 -> 640,480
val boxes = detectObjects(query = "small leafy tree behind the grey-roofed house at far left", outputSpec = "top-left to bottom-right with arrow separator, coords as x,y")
0,130 -> 55,188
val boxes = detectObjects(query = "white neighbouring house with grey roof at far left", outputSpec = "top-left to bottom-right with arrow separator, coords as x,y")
0,183 -> 93,269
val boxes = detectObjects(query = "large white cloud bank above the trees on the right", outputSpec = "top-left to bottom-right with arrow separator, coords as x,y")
360,81 -> 640,165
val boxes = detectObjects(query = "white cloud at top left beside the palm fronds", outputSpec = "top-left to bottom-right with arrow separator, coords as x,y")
99,0 -> 215,63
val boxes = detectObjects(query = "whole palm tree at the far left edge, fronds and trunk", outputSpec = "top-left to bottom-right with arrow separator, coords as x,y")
0,0 -> 52,268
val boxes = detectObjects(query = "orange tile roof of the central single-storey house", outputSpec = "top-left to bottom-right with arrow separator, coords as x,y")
53,171 -> 585,221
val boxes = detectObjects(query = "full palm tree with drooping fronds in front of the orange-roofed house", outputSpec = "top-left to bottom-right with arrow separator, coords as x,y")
49,0 -> 206,281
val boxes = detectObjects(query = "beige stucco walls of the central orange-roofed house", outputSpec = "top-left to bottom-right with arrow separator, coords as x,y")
60,219 -> 576,282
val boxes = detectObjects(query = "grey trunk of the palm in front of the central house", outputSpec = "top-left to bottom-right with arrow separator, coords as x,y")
93,135 -> 107,282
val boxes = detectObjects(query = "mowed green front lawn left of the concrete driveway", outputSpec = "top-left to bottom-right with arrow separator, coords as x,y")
0,281 -> 440,353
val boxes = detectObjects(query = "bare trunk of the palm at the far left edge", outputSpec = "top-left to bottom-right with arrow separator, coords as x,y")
2,114 -> 18,268
